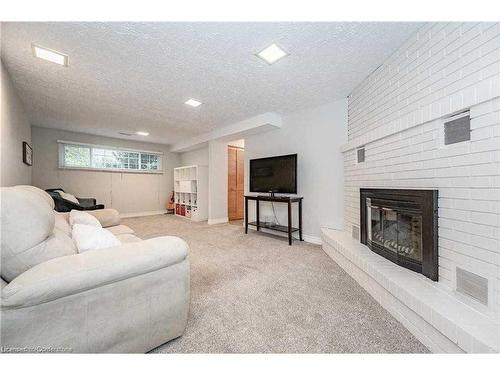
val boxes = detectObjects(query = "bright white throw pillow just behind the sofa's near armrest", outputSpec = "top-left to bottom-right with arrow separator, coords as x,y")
71,224 -> 121,253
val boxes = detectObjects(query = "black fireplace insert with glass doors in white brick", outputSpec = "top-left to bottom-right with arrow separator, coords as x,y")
360,189 -> 438,281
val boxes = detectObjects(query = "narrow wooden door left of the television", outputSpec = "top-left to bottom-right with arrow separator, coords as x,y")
227,146 -> 245,220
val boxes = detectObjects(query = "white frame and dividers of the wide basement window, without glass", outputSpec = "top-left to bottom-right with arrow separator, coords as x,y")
57,140 -> 163,174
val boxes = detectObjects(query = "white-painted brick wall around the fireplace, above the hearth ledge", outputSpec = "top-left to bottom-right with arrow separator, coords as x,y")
342,23 -> 500,312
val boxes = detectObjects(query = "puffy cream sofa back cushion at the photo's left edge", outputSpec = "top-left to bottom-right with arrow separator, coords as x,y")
0,187 -> 75,282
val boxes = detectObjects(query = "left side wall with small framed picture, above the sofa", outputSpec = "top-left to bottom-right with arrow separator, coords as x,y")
0,62 -> 31,186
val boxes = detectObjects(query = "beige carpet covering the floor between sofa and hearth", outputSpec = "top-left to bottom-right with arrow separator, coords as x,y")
123,215 -> 427,353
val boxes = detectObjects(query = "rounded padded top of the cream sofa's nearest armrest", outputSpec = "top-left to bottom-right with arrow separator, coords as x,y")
2,236 -> 188,309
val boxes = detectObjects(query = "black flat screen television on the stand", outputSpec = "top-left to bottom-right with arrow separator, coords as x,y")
250,154 -> 297,194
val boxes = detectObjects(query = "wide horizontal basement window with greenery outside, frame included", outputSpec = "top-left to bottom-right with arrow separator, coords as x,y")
58,141 -> 163,173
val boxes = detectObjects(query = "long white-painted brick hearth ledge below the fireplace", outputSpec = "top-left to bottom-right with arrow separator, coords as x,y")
322,228 -> 500,353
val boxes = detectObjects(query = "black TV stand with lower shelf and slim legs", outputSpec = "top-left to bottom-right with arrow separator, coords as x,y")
245,193 -> 303,245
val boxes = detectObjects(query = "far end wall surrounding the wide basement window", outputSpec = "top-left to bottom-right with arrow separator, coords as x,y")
32,127 -> 179,214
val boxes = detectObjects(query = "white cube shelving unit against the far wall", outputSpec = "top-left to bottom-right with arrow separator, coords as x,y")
174,165 -> 208,221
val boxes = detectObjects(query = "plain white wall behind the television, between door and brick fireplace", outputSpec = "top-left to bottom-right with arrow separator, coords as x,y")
245,99 -> 347,241
